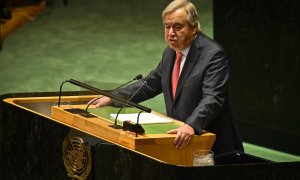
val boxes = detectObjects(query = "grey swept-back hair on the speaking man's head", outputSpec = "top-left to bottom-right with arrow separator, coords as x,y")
162,0 -> 201,32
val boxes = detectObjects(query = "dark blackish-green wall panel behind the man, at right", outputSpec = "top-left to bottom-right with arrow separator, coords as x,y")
214,0 -> 300,155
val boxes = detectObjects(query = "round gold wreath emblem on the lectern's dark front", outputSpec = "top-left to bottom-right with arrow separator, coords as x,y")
62,136 -> 92,179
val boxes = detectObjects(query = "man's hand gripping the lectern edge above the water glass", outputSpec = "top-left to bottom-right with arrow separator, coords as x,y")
167,124 -> 195,149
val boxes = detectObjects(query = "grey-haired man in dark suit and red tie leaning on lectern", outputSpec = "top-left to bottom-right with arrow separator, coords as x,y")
94,0 -> 243,154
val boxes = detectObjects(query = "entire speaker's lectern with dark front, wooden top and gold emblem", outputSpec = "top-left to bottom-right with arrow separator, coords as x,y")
0,91 -> 300,179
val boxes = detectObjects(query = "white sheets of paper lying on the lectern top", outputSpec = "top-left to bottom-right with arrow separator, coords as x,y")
110,113 -> 172,124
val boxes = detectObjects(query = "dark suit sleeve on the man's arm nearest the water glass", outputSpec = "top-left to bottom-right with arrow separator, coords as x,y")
185,49 -> 229,133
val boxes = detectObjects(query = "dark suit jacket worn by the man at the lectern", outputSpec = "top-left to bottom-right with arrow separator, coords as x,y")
115,33 -> 243,154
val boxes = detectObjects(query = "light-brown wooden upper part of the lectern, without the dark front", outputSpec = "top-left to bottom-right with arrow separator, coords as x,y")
5,95 -> 215,166
